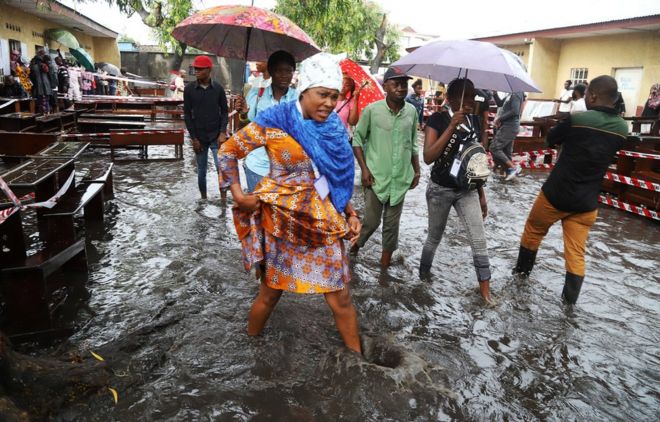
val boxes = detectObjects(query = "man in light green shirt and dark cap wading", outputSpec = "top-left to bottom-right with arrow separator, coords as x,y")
351,67 -> 419,267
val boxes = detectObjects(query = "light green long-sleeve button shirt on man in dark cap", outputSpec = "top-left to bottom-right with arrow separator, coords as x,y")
353,100 -> 419,206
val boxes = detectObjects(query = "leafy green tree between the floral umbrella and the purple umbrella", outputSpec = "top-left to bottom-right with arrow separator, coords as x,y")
275,0 -> 399,73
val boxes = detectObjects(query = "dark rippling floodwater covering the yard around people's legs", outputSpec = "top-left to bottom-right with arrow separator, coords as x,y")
6,137 -> 660,421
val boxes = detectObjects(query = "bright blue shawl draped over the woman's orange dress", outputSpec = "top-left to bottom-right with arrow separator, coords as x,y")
254,101 -> 355,213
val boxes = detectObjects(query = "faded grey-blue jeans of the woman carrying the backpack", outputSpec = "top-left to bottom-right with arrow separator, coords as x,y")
419,180 -> 490,281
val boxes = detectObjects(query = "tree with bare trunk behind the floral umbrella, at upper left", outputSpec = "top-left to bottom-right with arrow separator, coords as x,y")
105,0 -> 193,70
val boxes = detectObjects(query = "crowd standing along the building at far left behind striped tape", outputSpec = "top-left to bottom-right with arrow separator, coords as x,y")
0,49 -> 131,114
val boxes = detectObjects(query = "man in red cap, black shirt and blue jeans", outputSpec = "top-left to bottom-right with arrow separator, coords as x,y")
183,56 -> 229,199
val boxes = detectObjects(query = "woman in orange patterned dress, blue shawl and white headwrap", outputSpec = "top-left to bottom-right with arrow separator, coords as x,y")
219,53 -> 361,352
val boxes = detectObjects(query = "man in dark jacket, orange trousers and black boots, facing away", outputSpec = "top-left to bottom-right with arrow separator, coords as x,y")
514,75 -> 628,304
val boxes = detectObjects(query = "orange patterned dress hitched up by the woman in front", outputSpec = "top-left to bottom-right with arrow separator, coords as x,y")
218,123 -> 350,293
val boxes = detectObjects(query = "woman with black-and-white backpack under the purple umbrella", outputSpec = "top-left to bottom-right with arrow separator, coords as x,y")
419,79 -> 492,304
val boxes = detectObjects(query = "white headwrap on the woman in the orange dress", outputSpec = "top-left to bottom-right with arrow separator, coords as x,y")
298,53 -> 344,93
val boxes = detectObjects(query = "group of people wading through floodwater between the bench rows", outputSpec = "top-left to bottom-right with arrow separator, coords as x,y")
179,51 -> 640,352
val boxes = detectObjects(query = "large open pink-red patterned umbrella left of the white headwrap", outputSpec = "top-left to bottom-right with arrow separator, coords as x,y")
172,6 -> 320,61
